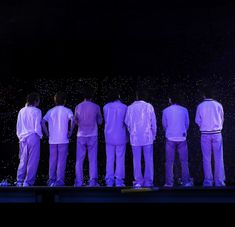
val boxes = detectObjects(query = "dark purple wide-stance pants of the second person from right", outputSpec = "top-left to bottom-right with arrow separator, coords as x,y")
166,140 -> 190,185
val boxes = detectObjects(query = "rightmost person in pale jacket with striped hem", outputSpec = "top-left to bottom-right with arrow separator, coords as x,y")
195,86 -> 225,187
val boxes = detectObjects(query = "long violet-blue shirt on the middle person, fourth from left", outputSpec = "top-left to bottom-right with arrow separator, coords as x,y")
103,100 -> 127,145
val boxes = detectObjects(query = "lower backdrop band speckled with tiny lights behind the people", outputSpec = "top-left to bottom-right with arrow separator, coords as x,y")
0,74 -> 235,185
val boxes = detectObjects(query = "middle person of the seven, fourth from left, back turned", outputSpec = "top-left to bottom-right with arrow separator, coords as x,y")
103,90 -> 127,187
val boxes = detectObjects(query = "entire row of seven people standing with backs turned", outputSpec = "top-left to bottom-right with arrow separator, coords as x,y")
16,90 -> 225,188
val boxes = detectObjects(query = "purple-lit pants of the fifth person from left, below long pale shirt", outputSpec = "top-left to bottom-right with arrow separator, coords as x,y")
132,144 -> 153,186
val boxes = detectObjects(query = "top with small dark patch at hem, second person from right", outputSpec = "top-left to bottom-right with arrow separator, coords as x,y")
162,104 -> 189,141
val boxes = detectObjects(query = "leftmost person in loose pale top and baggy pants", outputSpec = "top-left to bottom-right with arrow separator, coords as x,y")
16,93 -> 42,187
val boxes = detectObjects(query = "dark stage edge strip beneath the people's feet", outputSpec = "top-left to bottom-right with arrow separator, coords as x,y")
0,186 -> 235,204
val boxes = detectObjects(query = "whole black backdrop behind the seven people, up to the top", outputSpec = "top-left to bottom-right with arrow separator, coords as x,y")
0,0 -> 235,185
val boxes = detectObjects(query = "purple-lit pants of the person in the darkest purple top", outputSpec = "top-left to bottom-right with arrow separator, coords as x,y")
75,136 -> 98,186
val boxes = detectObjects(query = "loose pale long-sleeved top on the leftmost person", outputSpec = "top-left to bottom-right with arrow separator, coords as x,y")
16,106 -> 42,142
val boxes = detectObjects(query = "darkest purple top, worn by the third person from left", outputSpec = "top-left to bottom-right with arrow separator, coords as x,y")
75,101 -> 102,137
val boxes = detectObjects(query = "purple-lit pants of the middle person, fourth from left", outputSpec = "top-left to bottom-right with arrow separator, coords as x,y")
105,144 -> 126,184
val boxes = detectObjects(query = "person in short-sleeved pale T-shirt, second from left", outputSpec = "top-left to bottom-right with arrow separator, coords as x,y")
42,92 -> 73,187
